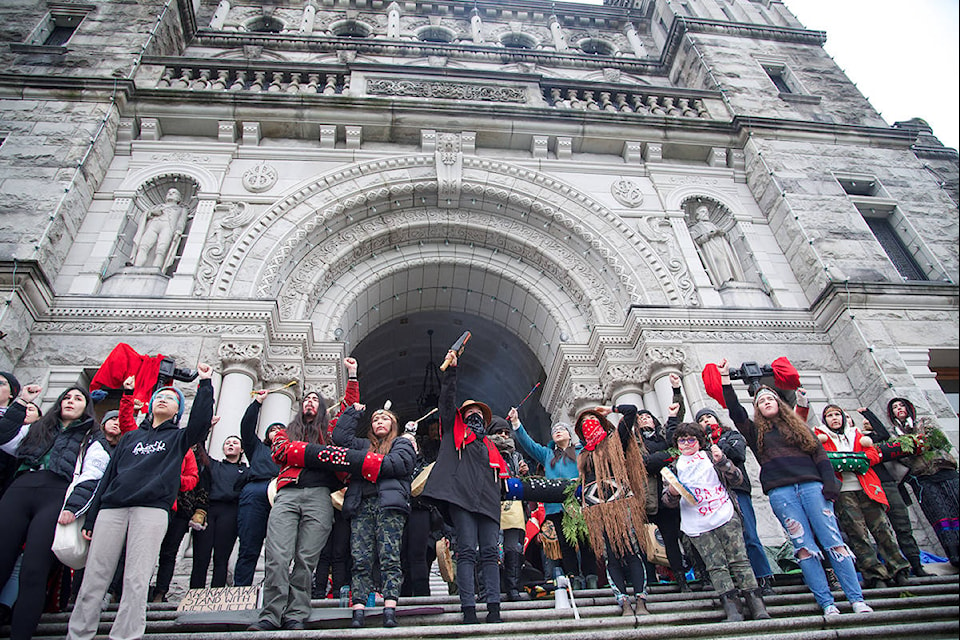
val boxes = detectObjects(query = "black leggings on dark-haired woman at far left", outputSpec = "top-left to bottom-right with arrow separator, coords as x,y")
0,471 -> 70,640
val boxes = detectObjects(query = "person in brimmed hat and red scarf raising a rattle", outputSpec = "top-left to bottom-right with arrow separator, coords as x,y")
422,351 -> 509,624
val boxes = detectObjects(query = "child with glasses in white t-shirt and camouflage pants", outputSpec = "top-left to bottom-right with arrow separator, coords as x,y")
662,422 -> 770,622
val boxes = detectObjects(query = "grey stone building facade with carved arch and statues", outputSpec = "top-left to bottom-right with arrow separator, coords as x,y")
0,0 -> 960,544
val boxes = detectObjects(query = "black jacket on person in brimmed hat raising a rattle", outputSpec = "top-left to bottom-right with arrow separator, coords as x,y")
421,367 -> 500,523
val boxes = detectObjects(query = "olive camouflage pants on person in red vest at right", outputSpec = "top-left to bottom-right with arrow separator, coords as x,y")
836,491 -> 910,580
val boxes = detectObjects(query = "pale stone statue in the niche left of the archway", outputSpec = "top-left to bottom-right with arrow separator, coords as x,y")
131,187 -> 188,272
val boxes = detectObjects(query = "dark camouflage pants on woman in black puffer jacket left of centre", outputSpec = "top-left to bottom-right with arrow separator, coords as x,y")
350,495 -> 407,604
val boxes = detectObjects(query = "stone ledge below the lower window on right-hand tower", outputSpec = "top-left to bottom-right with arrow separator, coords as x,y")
811,282 -> 960,332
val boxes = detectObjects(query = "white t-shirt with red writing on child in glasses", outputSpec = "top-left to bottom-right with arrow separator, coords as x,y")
677,451 -> 733,538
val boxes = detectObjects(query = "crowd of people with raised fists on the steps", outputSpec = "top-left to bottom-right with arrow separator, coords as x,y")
0,351 -> 960,640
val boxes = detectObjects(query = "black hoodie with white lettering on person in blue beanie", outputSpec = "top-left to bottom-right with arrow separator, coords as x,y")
83,379 -> 213,530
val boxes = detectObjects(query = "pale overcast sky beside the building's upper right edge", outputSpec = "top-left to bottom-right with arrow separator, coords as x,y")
567,0 -> 960,149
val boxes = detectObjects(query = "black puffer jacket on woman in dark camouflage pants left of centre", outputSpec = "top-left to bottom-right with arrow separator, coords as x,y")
333,407 -> 417,518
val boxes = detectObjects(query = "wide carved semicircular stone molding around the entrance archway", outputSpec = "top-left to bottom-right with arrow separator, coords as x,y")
213,154 -> 696,339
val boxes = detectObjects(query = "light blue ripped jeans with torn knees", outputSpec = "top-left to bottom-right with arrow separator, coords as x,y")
767,482 -> 863,608
